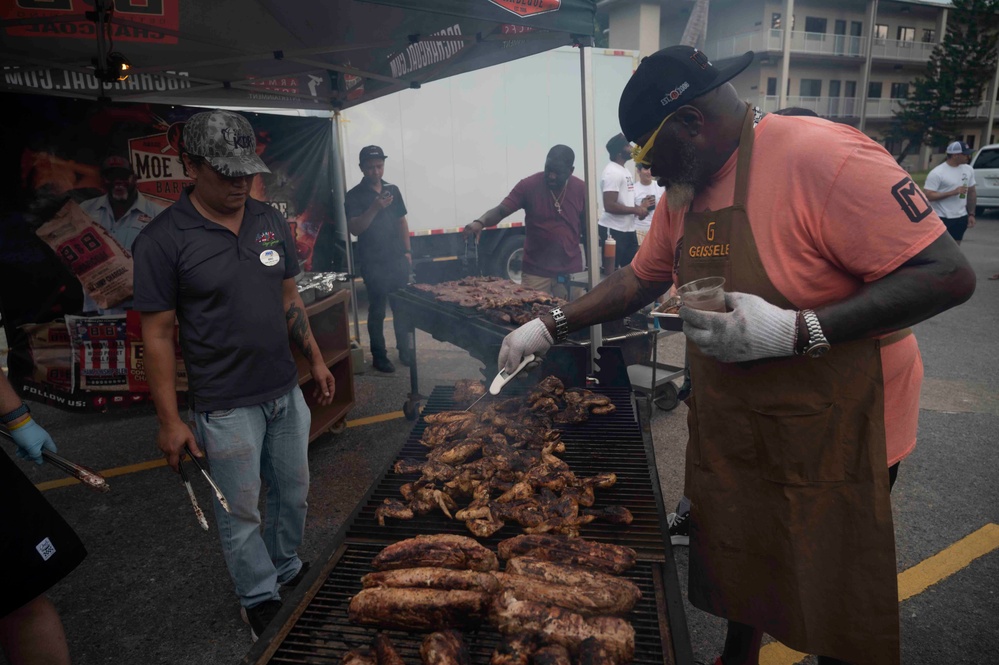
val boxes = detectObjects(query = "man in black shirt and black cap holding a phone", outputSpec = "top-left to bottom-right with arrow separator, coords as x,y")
344,145 -> 413,372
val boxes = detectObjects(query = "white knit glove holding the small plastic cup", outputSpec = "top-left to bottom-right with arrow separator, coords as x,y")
680,293 -> 798,363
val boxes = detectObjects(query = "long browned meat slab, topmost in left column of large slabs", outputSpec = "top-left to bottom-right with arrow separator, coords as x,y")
371,534 -> 499,571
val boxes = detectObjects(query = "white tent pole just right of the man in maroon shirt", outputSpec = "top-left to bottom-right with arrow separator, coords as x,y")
579,44 -> 603,374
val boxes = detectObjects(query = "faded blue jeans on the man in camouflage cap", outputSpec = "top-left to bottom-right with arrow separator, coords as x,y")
194,386 -> 312,607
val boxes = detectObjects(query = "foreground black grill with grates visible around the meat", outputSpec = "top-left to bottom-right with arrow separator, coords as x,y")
242,347 -> 693,665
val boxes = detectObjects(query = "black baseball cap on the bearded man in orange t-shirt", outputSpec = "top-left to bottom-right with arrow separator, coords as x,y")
617,46 -> 753,142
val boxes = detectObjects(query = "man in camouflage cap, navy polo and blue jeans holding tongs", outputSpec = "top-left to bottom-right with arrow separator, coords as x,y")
133,110 -> 335,640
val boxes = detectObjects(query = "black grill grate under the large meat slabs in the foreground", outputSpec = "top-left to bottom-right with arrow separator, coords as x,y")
270,543 -> 663,665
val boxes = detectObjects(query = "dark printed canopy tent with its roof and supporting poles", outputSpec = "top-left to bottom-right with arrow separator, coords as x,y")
0,0 -> 600,374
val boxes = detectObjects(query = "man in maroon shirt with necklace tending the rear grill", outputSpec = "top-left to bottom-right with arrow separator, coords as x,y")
465,145 -> 586,299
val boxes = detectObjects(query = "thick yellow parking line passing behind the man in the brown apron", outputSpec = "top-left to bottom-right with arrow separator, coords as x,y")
760,524 -> 999,665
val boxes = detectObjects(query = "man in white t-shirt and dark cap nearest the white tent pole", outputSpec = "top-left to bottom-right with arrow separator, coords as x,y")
597,134 -> 649,268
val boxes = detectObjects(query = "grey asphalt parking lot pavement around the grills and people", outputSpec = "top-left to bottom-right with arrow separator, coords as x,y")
0,211 -> 999,665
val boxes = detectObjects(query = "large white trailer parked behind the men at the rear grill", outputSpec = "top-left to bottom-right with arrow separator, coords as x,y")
341,47 -> 638,282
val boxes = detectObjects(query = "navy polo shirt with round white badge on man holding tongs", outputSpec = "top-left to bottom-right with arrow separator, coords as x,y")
132,191 -> 299,412
